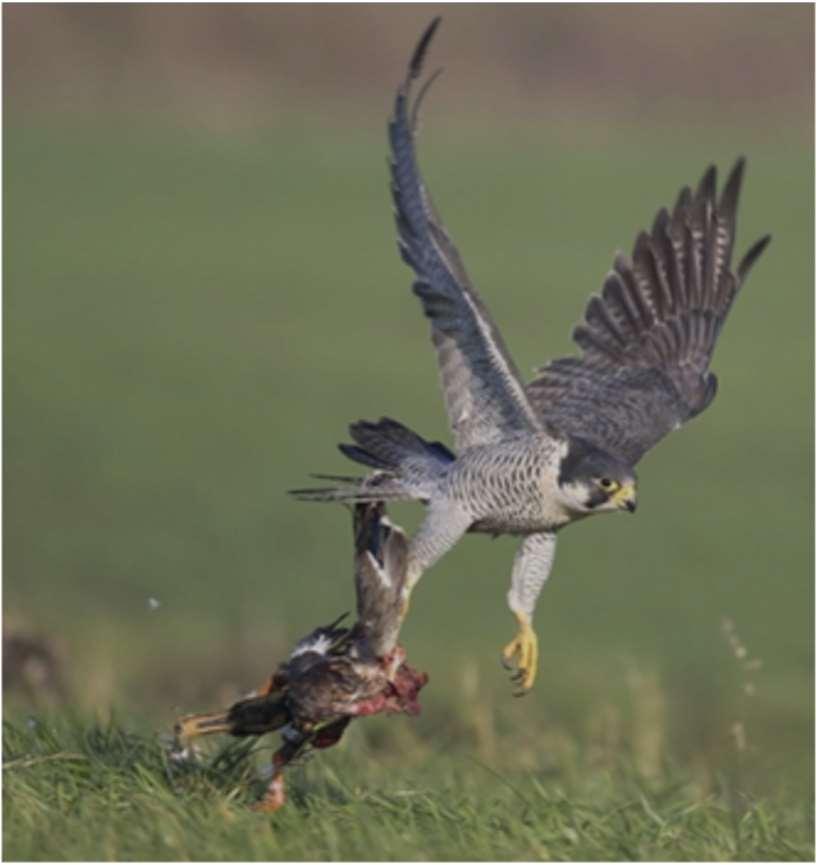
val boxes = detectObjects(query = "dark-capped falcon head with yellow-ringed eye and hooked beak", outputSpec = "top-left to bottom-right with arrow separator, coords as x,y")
557,438 -> 636,515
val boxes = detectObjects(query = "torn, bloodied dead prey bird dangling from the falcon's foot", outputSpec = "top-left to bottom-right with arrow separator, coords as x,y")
173,501 -> 428,811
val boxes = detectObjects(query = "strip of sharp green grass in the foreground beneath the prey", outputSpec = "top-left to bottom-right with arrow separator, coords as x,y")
4,722 -> 812,861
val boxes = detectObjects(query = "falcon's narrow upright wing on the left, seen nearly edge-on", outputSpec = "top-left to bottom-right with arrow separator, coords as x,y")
389,18 -> 540,449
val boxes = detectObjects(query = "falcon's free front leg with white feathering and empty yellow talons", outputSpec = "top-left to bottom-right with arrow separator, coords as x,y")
503,532 -> 557,696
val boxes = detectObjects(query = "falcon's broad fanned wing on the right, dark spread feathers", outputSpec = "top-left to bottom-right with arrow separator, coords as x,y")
527,159 -> 770,464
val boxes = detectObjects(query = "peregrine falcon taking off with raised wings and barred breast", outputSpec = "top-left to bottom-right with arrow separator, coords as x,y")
293,19 -> 770,693
